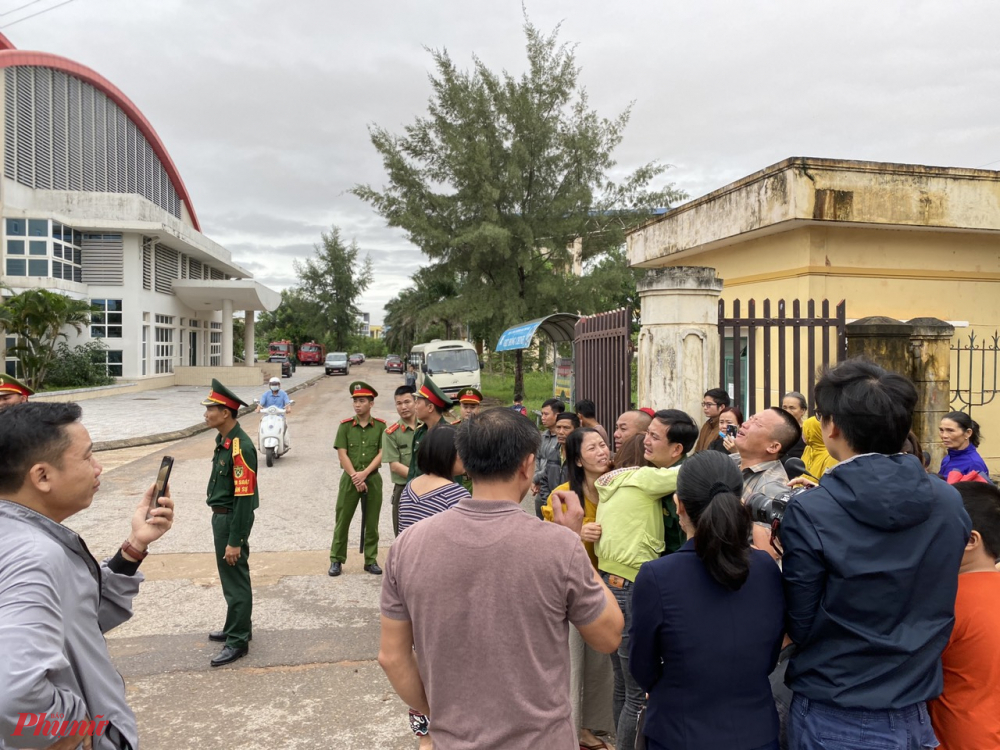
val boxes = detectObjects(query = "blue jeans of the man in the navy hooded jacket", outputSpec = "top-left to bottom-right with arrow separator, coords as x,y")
788,693 -> 938,750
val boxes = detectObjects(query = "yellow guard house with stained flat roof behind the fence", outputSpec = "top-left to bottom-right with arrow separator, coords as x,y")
628,158 -> 1000,466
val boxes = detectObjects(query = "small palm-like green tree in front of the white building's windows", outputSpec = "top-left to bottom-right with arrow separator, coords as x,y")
0,289 -> 90,390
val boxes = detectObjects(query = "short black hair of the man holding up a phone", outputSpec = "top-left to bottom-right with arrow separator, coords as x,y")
0,402 -> 82,493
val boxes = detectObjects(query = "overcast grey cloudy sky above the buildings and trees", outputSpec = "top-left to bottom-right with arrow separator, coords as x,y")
9,0 -> 1000,322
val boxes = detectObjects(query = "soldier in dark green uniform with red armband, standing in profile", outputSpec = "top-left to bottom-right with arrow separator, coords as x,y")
201,380 -> 260,667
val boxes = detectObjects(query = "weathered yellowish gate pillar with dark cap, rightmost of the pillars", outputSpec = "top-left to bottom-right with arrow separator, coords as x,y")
908,318 -> 955,471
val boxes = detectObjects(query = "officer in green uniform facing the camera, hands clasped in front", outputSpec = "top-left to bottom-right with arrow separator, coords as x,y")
328,380 -> 385,576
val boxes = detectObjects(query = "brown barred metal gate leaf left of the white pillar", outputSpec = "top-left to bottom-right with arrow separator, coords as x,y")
573,307 -> 632,434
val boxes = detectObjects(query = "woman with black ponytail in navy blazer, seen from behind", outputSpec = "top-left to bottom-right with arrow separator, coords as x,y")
629,451 -> 785,750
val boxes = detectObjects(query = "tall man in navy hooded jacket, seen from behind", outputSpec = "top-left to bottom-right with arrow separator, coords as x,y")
780,359 -> 972,750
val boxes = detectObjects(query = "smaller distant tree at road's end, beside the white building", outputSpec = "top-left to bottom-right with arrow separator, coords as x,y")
295,227 -> 373,350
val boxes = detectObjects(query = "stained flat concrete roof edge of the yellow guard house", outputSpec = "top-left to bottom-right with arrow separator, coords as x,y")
628,157 -> 1000,266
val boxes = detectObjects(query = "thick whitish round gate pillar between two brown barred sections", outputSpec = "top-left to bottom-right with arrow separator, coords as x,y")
637,266 -> 722,421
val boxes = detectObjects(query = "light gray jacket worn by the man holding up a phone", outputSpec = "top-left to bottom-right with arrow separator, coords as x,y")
0,499 -> 143,750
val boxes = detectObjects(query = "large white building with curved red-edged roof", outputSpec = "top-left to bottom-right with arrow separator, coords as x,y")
0,34 -> 281,385
